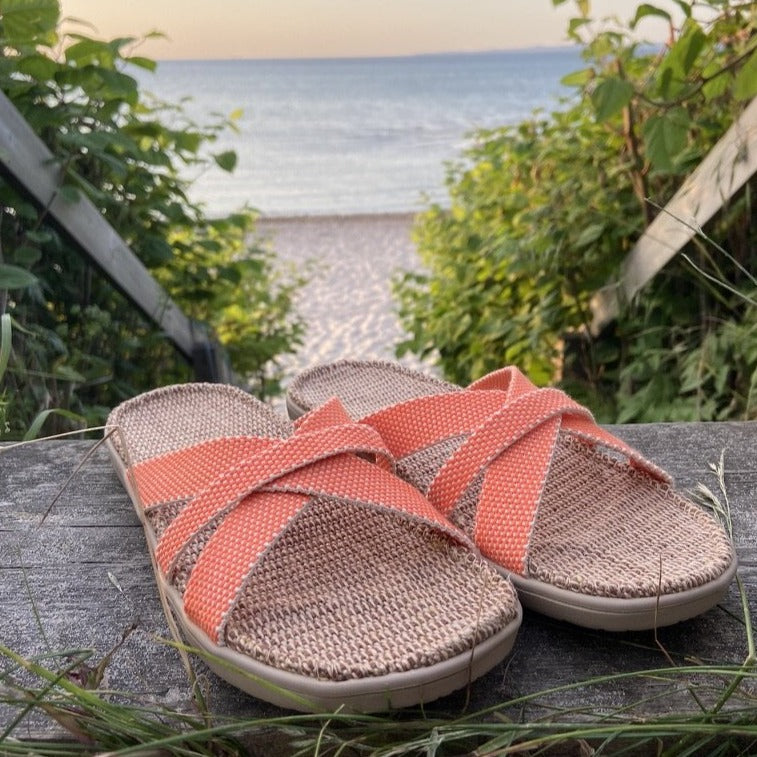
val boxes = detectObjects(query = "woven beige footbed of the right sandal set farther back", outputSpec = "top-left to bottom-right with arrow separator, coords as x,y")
288,360 -> 735,601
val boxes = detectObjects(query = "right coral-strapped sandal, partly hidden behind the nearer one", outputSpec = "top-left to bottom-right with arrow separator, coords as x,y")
287,360 -> 736,631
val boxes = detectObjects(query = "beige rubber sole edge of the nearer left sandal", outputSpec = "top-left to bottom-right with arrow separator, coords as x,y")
106,440 -> 523,713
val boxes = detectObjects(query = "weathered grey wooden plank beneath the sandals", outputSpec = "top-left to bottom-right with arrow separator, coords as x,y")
0,423 -> 757,736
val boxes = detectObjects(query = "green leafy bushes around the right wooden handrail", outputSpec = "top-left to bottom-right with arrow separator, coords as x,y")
396,0 -> 757,421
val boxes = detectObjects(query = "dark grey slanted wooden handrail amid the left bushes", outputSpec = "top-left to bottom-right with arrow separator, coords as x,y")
0,92 -> 195,359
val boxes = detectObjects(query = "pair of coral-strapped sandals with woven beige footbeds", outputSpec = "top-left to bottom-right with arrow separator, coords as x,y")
108,360 -> 736,712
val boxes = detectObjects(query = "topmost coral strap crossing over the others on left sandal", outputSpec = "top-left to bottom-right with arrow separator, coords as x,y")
156,423 -> 388,574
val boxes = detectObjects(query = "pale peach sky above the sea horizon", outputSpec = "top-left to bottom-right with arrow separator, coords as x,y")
61,0 -> 671,60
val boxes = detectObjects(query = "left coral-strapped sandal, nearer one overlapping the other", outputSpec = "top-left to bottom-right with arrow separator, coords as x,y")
108,384 -> 521,712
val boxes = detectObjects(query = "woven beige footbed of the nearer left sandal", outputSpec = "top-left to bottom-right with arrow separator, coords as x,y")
108,384 -> 519,681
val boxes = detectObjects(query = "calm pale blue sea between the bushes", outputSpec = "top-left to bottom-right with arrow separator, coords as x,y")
140,49 -> 581,216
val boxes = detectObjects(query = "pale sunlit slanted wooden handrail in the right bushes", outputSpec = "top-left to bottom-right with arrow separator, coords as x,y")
591,98 -> 757,334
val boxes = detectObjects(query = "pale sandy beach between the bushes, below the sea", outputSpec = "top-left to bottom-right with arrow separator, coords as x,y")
258,214 -> 429,384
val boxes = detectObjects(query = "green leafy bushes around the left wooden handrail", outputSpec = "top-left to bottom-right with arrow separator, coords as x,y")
0,0 -> 302,436
